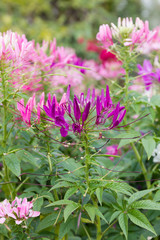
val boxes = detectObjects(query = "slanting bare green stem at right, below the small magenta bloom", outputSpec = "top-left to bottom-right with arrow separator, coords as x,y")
131,143 -> 151,189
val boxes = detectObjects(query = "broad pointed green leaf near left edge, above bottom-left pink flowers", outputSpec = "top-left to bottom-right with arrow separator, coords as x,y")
4,153 -> 21,177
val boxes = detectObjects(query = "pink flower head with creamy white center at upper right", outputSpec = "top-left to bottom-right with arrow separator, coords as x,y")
96,18 -> 156,49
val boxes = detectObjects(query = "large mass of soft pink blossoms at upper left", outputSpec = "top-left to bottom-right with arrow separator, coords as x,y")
0,31 -> 96,92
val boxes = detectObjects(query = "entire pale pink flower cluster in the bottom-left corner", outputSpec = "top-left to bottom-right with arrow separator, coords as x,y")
0,197 -> 40,225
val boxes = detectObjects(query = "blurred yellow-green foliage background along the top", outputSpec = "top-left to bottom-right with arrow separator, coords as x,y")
0,0 -> 160,57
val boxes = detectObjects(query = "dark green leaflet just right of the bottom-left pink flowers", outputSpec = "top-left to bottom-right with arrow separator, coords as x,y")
36,211 -> 58,232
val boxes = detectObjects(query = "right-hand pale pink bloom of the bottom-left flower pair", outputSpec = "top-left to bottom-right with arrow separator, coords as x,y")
12,197 -> 40,225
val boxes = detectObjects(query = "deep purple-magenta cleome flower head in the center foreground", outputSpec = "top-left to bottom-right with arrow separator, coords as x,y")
43,86 -> 126,137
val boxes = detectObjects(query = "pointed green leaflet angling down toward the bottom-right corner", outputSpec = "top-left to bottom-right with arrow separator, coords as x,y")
128,209 -> 156,235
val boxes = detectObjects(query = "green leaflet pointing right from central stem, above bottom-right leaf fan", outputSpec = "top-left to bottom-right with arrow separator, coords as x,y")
105,180 -> 131,195
